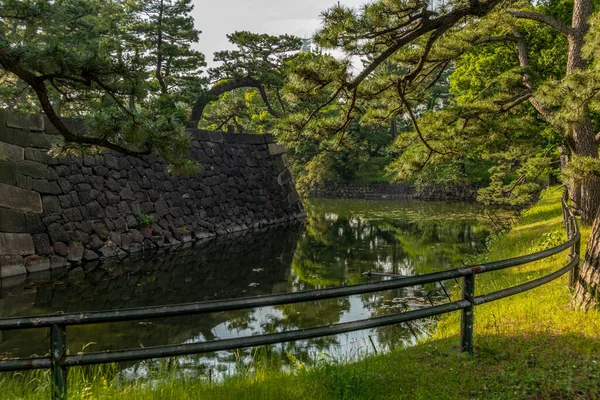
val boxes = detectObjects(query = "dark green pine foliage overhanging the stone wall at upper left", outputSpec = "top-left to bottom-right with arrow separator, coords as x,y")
0,0 -> 198,172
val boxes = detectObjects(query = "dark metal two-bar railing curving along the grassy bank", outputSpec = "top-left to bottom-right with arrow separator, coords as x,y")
0,192 -> 581,400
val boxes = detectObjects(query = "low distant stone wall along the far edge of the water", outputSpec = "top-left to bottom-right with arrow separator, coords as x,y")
311,182 -> 477,201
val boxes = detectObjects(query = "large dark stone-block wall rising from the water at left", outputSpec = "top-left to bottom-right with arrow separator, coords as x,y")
0,110 -> 304,278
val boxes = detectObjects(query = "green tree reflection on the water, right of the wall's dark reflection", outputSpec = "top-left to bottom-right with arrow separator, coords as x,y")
280,200 -> 490,354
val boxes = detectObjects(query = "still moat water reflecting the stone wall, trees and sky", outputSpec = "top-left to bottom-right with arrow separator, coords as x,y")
0,200 -> 506,376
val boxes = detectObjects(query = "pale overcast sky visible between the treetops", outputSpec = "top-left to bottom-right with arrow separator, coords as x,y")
192,0 -> 366,66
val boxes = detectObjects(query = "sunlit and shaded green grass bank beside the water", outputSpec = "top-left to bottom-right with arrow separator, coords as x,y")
0,189 -> 600,400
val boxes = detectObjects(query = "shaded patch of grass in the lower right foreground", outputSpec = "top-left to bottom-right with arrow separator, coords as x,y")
348,332 -> 600,400
